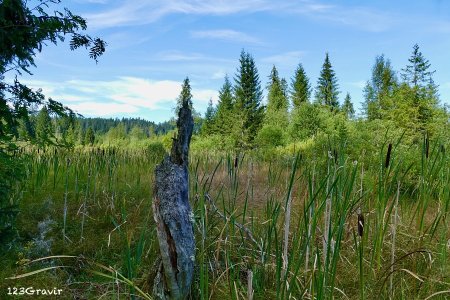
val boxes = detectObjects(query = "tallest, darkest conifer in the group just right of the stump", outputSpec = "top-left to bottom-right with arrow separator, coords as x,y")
235,50 -> 264,148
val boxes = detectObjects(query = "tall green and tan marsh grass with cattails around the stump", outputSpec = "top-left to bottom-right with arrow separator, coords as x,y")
0,138 -> 450,299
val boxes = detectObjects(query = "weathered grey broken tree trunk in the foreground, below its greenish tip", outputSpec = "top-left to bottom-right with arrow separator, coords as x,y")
153,101 -> 195,299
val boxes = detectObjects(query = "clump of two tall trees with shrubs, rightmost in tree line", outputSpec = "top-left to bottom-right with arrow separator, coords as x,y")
364,44 -> 442,137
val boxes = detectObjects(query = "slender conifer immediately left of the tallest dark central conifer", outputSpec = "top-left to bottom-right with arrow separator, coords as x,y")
215,76 -> 234,135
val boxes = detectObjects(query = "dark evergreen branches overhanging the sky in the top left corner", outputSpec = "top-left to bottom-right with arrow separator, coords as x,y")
0,0 -> 106,74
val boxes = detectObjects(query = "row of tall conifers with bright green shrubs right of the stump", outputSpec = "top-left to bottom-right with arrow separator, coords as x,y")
201,44 -> 447,149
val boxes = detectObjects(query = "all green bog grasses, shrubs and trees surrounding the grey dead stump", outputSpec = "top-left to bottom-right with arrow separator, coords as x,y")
0,1 -> 450,299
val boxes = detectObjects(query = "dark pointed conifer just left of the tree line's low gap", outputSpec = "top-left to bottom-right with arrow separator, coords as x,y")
315,53 -> 339,111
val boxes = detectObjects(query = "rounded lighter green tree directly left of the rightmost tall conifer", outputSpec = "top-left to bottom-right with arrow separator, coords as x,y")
363,55 -> 398,121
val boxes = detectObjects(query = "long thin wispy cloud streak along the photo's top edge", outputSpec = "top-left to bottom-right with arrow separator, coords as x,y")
86,0 -> 398,32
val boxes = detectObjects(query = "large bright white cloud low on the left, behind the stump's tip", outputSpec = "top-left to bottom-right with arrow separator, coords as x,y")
24,77 -> 217,116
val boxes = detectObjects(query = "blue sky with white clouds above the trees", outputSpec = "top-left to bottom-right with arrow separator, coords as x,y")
19,0 -> 450,122
